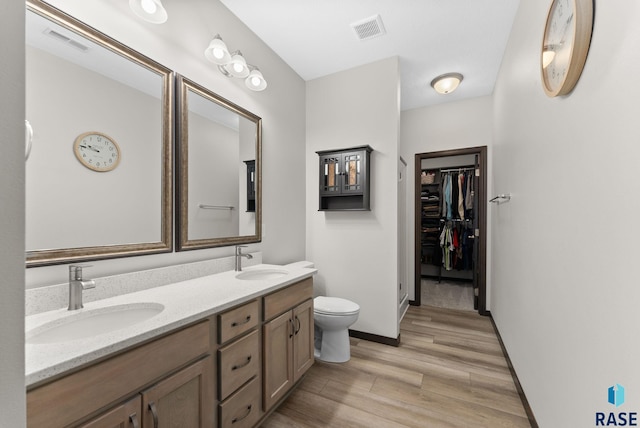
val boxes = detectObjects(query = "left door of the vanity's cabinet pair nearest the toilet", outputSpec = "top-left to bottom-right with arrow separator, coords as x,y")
263,311 -> 293,411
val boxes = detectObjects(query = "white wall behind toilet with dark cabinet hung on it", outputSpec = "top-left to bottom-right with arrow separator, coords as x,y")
306,58 -> 400,338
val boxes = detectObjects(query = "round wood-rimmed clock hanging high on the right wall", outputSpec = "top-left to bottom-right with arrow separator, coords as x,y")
540,0 -> 593,97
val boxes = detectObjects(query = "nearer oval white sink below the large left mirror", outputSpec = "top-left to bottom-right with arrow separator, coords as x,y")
26,303 -> 164,344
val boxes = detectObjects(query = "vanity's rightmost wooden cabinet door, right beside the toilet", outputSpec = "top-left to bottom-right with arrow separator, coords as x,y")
292,300 -> 314,382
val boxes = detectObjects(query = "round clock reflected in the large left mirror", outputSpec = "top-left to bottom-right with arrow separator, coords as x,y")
73,132 -> 120,172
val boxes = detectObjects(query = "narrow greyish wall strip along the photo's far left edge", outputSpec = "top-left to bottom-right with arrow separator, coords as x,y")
0,0 -> 26,422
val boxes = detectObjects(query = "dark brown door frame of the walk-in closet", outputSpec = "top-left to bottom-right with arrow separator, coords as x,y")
409,146 -> 489,315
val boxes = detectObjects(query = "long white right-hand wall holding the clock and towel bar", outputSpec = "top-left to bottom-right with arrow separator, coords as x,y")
491,0 -> 640,427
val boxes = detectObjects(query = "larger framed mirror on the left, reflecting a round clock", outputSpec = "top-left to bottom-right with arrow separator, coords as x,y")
26,0 -> 174,267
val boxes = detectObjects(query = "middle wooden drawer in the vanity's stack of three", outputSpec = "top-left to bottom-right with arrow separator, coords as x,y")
218,330 -> 260,401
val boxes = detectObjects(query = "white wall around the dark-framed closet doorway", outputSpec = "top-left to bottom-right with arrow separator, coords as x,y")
400,96 -> 493,300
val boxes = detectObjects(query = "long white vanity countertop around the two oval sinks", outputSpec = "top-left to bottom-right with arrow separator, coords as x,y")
25,263 -> 316,386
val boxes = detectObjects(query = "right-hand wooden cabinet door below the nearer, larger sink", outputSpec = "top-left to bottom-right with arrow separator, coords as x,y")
142,357 -> 214,428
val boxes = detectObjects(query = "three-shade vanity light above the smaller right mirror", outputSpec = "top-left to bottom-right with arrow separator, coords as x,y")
204,34 -> 267,91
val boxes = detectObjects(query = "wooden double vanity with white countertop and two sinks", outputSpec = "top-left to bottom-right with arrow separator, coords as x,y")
26,263 -> 316,428
